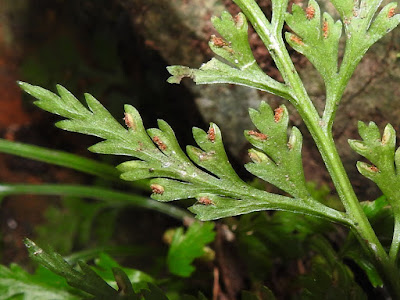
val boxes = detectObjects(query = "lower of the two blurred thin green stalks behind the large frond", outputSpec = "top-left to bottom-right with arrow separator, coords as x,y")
0,184 -> 194,220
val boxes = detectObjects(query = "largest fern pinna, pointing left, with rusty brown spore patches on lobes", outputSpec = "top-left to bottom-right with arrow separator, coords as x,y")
20,82 -> 349,225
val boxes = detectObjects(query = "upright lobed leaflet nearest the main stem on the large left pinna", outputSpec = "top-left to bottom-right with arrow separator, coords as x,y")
245,102 -> 309,199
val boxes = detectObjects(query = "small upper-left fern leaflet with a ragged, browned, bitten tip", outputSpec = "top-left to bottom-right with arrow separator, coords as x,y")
167,12 -> 291,99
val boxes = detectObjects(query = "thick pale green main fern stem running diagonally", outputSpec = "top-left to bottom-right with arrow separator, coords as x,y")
235,0 -> 400,299
